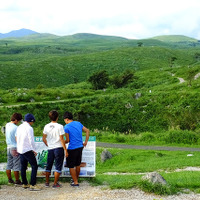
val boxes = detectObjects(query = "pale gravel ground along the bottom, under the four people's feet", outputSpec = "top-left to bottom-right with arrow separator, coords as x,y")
0,182 -> 200,200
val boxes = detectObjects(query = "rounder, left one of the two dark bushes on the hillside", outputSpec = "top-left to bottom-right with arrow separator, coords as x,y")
88,70 -> 109,90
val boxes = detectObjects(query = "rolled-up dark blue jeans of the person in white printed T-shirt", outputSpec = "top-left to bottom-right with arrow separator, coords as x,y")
46,147 -> 64,174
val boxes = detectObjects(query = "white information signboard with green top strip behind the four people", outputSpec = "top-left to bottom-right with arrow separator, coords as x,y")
35,136 -> 96,177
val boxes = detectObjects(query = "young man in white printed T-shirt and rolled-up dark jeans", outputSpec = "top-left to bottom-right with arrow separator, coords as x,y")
43,110 -> 68,188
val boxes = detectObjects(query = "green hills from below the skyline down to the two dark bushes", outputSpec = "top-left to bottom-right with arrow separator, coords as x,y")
0,34 -> 199,89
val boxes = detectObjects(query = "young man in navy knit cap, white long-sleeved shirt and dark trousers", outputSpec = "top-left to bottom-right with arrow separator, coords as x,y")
17,113 -> 40,191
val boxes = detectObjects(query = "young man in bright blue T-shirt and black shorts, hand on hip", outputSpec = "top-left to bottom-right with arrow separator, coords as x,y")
63,112 -> 90,187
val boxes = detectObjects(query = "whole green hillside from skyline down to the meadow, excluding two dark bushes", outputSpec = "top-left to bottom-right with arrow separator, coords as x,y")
0,34 -> 200,138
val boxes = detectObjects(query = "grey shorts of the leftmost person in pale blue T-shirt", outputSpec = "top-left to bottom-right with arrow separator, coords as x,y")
6,147 -> 21,171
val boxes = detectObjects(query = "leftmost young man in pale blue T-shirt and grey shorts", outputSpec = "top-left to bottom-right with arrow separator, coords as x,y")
6,113 -> 22,185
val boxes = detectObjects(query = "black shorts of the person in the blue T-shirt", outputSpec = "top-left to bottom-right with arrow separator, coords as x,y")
66,147 -> 83,168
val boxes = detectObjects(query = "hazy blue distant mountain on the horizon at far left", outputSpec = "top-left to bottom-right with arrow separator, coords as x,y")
0,28 -> 38,39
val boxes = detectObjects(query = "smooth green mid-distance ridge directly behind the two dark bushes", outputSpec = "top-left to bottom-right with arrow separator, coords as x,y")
0,47 -> 199,89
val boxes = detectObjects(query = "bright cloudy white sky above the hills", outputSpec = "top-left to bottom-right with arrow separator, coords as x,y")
0,0 -> 200,39
